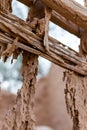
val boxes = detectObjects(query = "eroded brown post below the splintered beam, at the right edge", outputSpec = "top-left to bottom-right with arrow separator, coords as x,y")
65,72 -> 87,130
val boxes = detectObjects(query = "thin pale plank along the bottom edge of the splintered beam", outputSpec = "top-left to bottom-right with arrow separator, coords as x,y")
0,33 -> 87,75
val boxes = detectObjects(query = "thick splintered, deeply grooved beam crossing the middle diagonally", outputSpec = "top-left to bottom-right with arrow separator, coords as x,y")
0,12 -> 87,75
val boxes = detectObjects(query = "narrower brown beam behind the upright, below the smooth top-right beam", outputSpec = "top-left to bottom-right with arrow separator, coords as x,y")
18,0 -> 83,38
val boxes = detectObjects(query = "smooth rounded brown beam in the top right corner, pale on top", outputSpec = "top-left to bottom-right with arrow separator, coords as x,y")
42,0 -> 87,30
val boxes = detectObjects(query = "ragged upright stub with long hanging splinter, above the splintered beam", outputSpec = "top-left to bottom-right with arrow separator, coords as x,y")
27,0 -> 52,51
